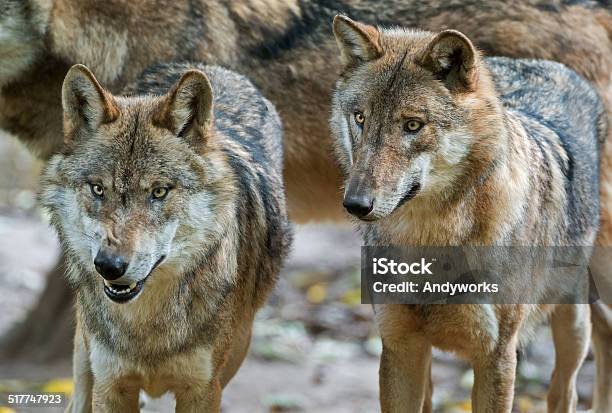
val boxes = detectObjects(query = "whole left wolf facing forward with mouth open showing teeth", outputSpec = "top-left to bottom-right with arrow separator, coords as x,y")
40,63 -> 291,413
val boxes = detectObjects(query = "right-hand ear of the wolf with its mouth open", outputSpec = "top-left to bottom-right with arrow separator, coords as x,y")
158,70 -> 213,142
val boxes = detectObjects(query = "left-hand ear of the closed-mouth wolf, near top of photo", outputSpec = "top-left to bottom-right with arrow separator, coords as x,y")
333,14 -> 383,66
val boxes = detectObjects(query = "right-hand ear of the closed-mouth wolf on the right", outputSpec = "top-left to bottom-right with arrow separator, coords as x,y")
423,30 -> 478,92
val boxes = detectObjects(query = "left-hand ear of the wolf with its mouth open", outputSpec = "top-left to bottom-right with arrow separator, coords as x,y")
62,65 -> 119,140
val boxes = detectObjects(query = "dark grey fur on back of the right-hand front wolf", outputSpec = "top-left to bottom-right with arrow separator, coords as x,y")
486,58 -> 607,242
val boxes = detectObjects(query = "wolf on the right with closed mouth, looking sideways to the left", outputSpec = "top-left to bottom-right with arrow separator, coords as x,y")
330,15 -> 607,413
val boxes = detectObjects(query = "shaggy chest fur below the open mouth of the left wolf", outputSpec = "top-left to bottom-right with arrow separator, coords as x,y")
77,257 -> 233,360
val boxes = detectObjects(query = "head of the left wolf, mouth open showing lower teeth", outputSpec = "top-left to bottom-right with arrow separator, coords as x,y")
41,65 -> 228,302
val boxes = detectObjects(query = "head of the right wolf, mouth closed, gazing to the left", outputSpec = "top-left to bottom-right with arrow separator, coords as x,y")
331,16 -> 500,221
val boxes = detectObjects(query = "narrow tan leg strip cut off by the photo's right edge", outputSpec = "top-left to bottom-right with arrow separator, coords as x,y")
591,301 -> 612,413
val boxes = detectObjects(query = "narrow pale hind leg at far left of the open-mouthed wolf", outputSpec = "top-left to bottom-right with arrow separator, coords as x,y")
66,322 -> 93,413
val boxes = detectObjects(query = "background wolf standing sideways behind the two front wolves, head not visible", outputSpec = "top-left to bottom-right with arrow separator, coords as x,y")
0,0 -> 612,224
